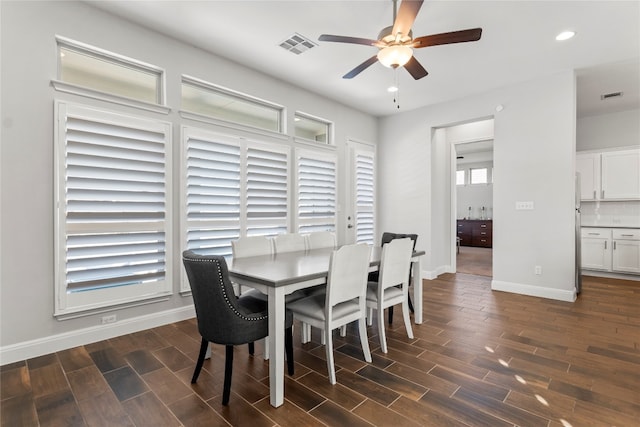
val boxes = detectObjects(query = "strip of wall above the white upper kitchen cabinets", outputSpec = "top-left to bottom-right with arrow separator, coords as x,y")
576,110 -> 640,151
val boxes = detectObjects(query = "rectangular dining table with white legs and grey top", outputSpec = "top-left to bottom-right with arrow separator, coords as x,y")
229,246 -> 425,407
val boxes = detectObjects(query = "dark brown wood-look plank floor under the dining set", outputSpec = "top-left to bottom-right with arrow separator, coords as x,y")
1,274 -> 640,427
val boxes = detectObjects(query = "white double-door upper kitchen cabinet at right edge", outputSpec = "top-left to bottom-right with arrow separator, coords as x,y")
576,149 -> 640,200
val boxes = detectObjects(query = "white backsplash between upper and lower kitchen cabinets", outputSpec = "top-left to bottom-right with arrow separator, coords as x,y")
580,201 -> 640,227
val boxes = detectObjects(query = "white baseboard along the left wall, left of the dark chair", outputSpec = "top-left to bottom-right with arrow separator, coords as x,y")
0,305 -> 196,365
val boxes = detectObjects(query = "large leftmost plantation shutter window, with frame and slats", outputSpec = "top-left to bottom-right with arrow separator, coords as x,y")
55,102 -> 171,316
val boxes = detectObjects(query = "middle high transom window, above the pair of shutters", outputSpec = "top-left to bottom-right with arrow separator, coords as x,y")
181,76 -> 284,133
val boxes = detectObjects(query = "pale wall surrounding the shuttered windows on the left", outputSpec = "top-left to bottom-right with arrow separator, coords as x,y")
0,1 -> 377,364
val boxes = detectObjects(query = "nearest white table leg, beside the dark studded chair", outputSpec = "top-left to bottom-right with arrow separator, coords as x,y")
268,288 -> 285,408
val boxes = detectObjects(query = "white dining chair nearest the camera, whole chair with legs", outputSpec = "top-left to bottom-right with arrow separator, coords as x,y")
287,244 -> 371,384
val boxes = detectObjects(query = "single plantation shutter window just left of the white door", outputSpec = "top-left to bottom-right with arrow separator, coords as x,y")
296,150 -> 337,233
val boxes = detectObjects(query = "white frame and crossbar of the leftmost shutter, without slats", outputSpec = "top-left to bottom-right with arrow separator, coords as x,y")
54,100 -> 173,320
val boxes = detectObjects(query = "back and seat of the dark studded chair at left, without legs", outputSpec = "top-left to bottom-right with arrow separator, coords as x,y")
182,251 -> 268,345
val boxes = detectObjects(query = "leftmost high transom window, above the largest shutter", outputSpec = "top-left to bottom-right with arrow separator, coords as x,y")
56,37 -> 164,104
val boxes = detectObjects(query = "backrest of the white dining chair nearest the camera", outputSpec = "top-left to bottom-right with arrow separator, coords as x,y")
327,243 -> 371,307
